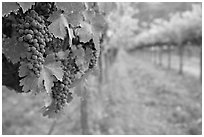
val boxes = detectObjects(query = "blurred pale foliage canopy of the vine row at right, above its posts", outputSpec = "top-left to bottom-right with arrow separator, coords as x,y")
134,5 -> 202,47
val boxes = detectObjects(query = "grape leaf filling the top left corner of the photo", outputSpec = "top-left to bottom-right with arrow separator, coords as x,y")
2,2 -> 19,16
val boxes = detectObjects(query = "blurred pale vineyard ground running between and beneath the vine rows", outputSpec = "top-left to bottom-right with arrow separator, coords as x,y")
2,49 -> 202,135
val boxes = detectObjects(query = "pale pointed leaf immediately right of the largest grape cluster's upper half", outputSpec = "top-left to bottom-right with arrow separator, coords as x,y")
48,14 -> 69,39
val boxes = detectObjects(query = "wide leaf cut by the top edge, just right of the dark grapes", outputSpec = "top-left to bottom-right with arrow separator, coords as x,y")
56,2 -> 85,14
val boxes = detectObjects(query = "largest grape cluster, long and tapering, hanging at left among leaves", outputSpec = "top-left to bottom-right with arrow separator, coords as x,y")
16,10 -> 53,77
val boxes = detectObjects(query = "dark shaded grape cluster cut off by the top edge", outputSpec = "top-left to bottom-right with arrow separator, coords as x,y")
34,2 -> 57,18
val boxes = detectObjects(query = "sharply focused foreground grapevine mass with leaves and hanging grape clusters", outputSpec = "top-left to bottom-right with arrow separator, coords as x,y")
2,2 -> 103,117
